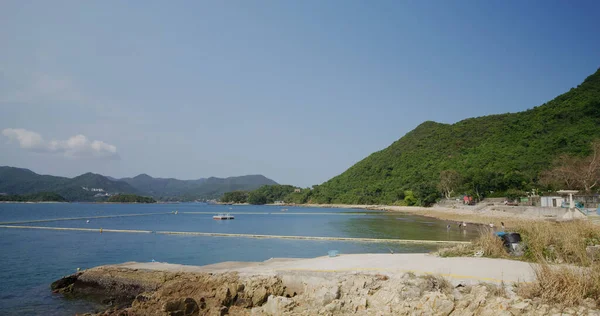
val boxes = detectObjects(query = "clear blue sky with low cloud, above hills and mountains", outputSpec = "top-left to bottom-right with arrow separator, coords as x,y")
0,0 -> 600,187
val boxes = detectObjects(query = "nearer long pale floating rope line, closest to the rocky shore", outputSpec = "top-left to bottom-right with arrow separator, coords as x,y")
0,225 -> 470,245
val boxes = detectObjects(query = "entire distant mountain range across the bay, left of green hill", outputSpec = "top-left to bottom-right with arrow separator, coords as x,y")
0,166 -> 277,201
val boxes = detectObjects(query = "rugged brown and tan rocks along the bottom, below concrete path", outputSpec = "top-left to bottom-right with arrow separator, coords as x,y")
52,267 -> 600,316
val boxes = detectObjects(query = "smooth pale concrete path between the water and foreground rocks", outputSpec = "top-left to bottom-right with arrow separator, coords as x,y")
109,254 -> 534,284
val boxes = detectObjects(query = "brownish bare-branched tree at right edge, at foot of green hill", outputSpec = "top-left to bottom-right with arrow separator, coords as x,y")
540,140 -> 600,193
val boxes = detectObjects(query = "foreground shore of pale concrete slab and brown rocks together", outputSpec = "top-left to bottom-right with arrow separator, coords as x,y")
51,254 -> 598,316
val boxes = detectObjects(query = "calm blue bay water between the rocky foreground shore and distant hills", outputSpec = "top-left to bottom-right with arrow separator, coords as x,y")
0,203 -> 477,315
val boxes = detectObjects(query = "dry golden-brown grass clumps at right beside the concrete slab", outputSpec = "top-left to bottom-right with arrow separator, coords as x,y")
439,220 -> 600,306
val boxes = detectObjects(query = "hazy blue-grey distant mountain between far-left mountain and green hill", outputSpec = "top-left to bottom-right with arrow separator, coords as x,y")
120,174 -> 277,200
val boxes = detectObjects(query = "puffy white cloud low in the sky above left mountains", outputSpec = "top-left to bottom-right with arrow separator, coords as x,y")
2,128 -> 119,159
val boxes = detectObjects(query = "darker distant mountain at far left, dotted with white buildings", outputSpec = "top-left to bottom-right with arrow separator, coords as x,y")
0,167 -> 139,201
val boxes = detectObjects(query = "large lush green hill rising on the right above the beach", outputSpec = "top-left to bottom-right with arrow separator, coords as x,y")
310,70 -> 600,204
